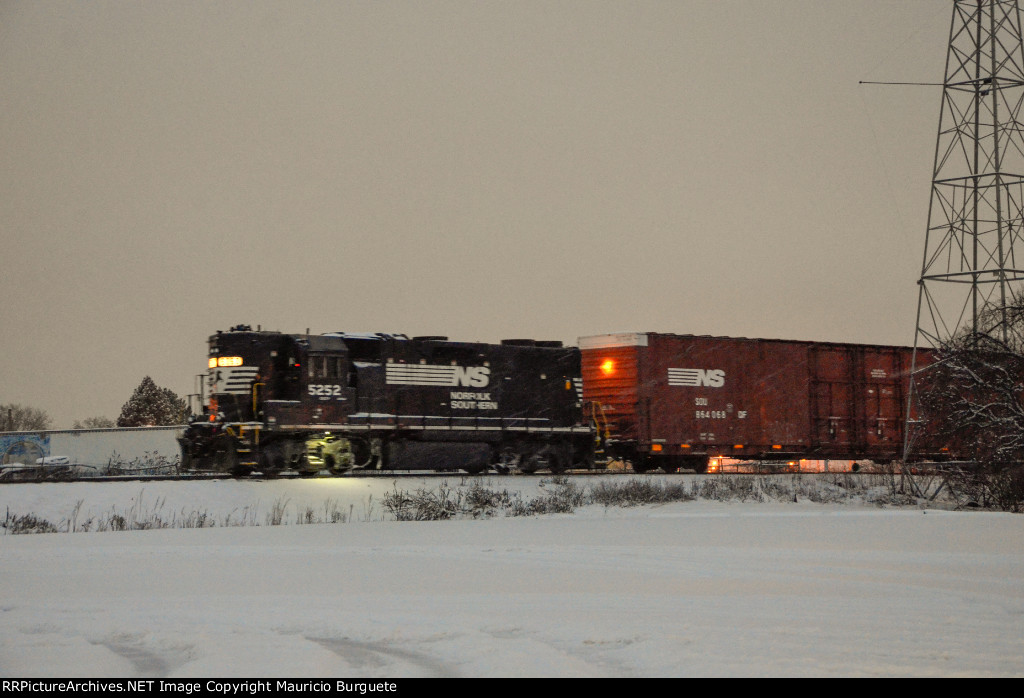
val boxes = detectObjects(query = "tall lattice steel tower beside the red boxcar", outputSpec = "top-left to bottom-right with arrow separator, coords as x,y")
903,0 -> 1024,463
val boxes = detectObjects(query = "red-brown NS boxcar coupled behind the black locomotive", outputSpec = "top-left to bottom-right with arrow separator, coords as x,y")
580,333 -> 928,471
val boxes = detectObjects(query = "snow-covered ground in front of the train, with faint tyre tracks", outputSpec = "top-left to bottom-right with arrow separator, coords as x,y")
0,476 -> 1024,678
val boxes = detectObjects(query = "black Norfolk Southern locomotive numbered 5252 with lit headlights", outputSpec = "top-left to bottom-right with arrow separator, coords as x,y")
180,325 -> 594,475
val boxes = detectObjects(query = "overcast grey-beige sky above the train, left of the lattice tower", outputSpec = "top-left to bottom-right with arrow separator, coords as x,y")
0,0 -> 952,428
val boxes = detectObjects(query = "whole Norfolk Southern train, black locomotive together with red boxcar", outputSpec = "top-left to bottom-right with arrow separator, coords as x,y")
181,325 -> 944,475
